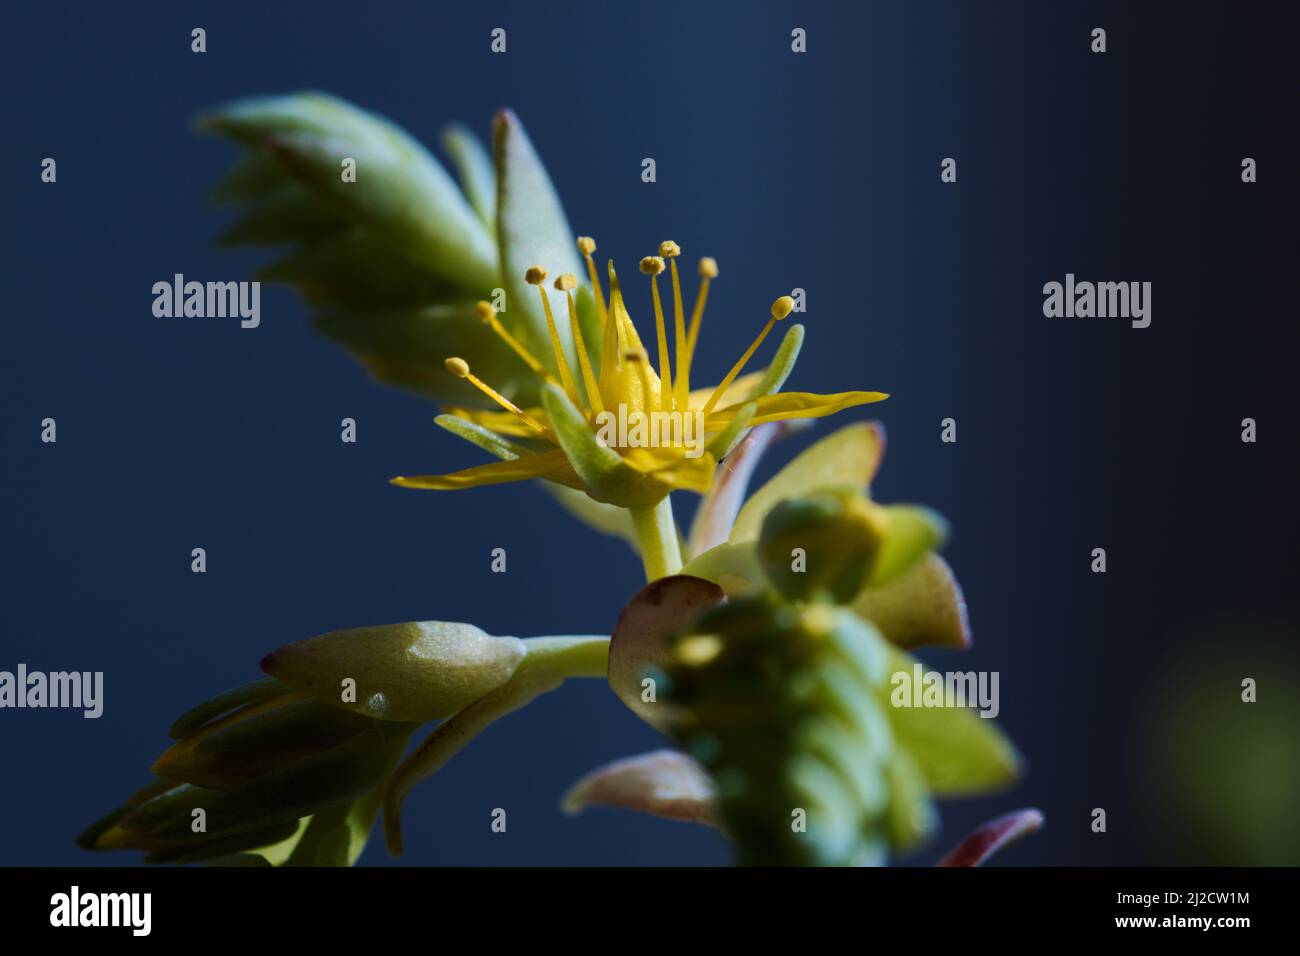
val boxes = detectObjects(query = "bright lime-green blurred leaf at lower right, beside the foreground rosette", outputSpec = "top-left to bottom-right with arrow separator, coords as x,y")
878,648 -> 1021,796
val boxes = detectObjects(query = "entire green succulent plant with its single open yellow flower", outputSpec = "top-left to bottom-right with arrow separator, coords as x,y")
81,94 -> 1041,865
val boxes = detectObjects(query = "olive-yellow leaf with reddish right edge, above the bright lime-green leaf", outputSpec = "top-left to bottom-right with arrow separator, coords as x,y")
853,553 -> 970,648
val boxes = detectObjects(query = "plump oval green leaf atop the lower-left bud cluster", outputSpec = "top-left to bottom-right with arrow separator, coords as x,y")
261,620 -> 525,722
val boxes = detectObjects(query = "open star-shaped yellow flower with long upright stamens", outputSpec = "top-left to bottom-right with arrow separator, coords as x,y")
393,237 -> 887,507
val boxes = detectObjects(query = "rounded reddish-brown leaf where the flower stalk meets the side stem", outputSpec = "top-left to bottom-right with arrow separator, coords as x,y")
610,575 -> 727,727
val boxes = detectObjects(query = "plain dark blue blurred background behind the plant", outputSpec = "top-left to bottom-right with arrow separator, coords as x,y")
0,0 -> 1300,864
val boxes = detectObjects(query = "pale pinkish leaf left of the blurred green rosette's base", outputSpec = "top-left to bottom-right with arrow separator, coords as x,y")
560,749 -> 718,826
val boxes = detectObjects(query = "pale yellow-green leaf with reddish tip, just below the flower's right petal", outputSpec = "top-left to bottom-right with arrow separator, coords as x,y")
731,423 -> 884,542
